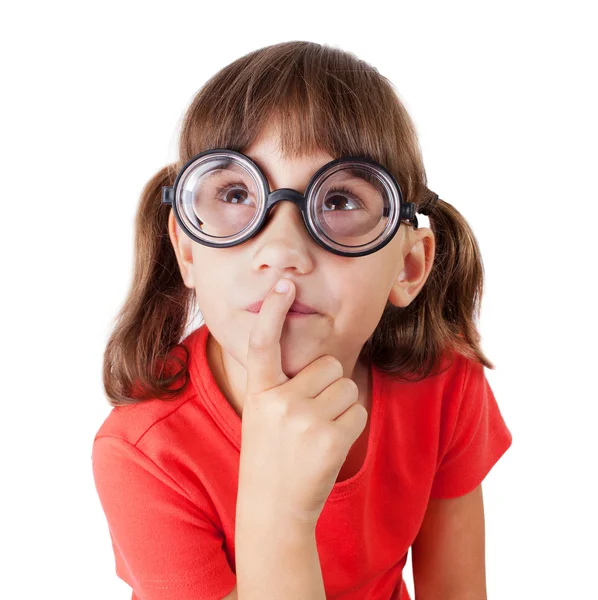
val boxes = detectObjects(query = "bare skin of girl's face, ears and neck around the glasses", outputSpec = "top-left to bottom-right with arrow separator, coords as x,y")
168,123 -> 435,417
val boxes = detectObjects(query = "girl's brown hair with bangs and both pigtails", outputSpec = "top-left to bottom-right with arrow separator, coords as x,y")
103,41 -> 494,406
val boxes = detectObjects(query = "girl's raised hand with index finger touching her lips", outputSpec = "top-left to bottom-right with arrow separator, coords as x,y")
237,281 -> 368,528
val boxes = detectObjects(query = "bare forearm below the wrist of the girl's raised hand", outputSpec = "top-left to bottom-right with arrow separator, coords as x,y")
235,515 -> 326,600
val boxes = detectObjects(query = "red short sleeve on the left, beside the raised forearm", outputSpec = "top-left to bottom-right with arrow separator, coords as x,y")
92,436 -> 236,600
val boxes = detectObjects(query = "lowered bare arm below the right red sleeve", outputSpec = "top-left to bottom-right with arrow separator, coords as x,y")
411,484 -> 487,600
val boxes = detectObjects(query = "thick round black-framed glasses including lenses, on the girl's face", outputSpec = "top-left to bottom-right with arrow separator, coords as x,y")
162,148 -> 418,257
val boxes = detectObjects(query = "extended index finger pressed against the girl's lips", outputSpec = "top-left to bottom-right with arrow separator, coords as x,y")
245,279 -> 295,394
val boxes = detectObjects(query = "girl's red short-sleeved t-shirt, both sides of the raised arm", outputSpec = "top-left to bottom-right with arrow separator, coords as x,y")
92,324 -> 512,600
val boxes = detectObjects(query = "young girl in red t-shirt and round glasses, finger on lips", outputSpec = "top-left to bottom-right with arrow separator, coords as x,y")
92,41 -> 511,600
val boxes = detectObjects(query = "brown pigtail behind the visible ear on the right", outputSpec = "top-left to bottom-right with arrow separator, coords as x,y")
361,188 -> 495,381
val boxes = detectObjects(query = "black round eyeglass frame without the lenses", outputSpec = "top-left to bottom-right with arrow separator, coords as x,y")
162,148 -> 418,257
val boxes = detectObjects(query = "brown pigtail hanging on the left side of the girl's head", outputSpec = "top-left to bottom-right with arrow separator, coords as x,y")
103,165 -> 196,406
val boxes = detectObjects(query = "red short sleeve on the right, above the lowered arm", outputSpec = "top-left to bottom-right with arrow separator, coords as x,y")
431,360 -> 512,498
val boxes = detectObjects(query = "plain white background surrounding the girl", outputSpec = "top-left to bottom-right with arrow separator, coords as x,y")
0,1 -> 598,600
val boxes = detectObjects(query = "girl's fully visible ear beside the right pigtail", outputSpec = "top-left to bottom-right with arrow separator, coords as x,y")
388,227 -> 436,308
